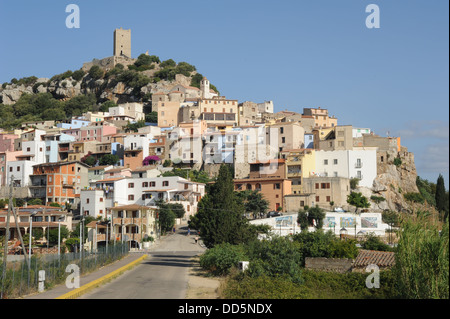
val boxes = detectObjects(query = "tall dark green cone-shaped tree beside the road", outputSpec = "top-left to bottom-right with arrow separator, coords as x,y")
189,164 -> 254,248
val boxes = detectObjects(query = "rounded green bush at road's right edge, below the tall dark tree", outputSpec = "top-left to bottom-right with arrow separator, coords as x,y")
200,243 -> 247,276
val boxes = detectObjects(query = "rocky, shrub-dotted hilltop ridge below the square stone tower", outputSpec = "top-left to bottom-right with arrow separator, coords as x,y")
0,55 -> 215,105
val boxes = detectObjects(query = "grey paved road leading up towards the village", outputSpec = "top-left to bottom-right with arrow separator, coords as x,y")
79,228 -> 204,299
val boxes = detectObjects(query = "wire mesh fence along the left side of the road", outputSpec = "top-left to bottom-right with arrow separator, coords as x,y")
0,242 -> 129,299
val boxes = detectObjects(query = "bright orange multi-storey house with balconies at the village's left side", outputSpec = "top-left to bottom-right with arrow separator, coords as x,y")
30,161 -> 90,205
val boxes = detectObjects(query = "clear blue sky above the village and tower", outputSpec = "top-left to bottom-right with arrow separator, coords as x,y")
0,0 -> 449,188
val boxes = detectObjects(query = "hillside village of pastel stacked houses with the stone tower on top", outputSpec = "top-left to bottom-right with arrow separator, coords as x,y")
0,29 -> 430,252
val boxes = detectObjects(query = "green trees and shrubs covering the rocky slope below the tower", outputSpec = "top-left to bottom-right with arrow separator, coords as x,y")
0,54 -> 218,130
